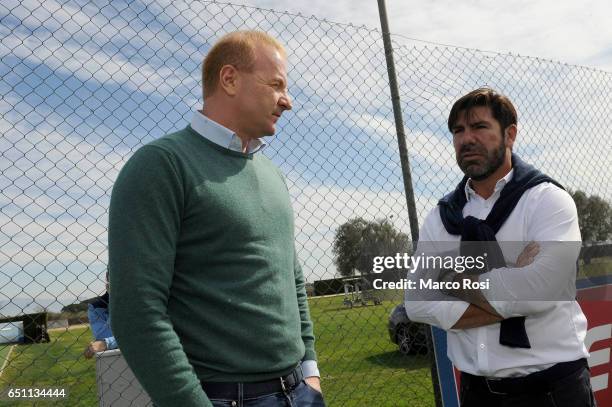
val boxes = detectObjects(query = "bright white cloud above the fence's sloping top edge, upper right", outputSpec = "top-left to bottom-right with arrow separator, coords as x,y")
225,0 -> 612,71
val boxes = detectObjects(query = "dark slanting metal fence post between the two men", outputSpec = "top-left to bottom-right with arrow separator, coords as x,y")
378,0 -> 442,407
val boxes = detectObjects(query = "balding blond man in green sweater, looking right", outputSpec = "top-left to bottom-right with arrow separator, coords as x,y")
109,31 -> 324,407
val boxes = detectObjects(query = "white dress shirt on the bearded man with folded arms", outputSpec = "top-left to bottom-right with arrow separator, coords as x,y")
405,170 -> 588,378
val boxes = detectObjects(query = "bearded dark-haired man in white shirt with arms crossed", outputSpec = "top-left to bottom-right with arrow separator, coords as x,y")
405,88 -> 595,407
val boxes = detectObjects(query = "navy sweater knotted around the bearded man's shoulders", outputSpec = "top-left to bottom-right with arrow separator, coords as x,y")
438,154 -> 563,348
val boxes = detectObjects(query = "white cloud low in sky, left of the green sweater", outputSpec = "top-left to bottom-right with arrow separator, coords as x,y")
0,121 -> 128,298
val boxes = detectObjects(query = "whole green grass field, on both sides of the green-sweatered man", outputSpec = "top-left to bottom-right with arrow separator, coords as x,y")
0,296 -> 434,407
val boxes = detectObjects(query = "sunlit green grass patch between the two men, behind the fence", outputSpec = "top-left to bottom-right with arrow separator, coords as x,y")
310,296 -> 434,407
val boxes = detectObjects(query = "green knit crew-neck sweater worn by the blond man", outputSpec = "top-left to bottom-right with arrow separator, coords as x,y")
108,127 -> 316,406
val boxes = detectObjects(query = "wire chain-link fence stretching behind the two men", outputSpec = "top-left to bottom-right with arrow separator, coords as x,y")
0,0 -> 612,406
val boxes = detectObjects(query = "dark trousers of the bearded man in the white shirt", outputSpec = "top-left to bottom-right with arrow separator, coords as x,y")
460,367 -> 597,407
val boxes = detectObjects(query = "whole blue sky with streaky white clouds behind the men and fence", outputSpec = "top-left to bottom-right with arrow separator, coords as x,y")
0,0 -> 612,312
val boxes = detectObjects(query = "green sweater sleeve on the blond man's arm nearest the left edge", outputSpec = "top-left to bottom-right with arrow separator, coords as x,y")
108,146 -> 212,407
